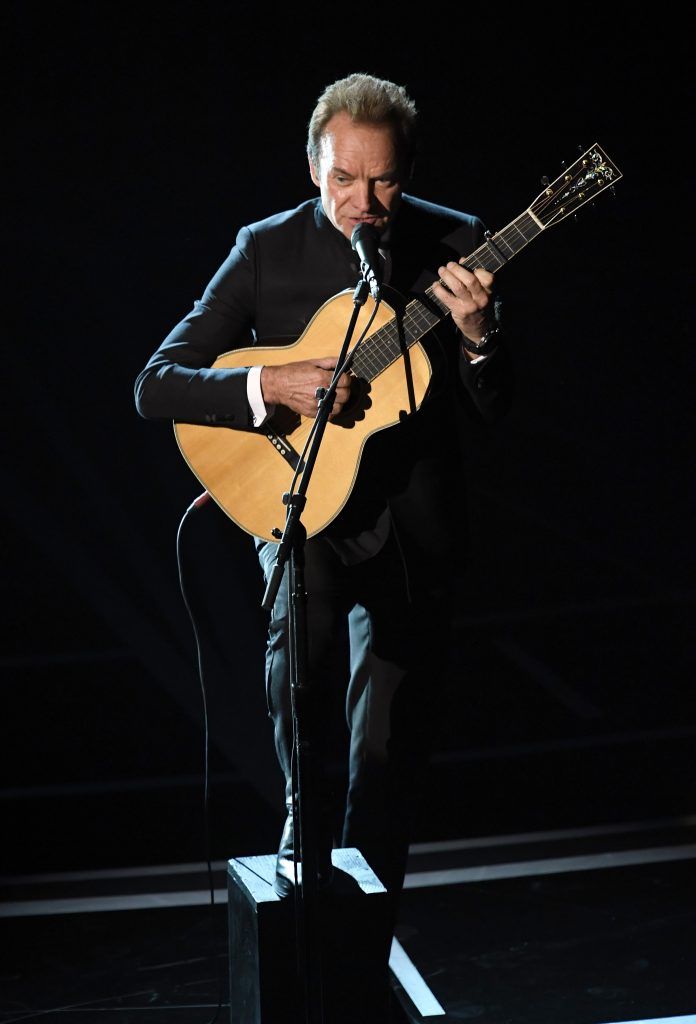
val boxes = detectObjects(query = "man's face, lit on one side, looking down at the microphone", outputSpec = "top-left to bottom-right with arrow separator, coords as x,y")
309,113 -> 401,239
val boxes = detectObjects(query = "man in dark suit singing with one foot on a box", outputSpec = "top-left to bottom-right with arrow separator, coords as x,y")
136,74 -> 509,999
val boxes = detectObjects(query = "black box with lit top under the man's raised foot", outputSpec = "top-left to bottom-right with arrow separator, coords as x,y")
227,849 -> 391,1024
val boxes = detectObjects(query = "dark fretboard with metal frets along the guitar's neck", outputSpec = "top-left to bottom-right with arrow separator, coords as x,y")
352,210 -> 543,381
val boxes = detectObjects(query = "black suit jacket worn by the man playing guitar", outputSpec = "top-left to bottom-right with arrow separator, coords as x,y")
135,196 -> 510,577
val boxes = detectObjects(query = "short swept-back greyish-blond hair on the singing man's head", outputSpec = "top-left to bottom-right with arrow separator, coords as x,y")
307,74 -> 418,170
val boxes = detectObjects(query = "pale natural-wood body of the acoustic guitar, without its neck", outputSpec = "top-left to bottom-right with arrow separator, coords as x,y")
174,289 -> 432,541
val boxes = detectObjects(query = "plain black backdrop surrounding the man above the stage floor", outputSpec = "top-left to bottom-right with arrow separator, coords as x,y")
2,2 -> 696,872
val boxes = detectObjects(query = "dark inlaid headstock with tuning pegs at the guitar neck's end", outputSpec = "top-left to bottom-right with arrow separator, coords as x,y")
529,143 -> 623,227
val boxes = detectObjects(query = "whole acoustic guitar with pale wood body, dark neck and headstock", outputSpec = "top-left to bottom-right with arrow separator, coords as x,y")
174,144 -> 622,541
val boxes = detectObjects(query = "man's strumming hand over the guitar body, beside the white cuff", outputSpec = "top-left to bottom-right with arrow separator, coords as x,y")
261,355 -> 350,419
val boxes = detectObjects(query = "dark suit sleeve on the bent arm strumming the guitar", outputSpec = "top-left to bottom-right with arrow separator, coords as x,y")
135,227 -> 256,430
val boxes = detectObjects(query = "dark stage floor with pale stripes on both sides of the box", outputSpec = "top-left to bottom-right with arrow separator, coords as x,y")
0,817 -> 696,1024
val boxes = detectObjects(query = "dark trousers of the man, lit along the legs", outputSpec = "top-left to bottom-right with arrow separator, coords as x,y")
257,526 -> 449,921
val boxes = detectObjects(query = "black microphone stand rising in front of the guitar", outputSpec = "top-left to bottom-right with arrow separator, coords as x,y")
261,271 -> 369,1024
